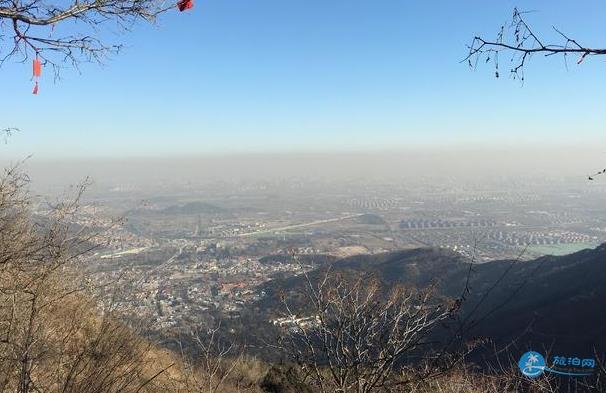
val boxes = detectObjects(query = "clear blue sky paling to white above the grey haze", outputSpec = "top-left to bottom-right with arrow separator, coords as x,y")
0,0 -> 606,160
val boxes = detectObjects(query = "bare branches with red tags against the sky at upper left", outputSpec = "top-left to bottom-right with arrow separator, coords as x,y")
0,0 -> 185,75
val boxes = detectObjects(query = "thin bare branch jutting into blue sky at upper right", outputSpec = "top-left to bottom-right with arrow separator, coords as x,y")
464,8 -> 606,81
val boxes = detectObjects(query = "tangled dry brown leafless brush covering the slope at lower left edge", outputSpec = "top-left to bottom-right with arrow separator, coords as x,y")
0,167 -> 176,393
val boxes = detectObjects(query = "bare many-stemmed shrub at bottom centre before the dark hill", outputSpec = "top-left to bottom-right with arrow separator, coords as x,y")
280,271 -> 458,393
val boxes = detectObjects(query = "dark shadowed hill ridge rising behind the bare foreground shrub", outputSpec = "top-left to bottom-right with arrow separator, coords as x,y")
258,244 -> 606,354
